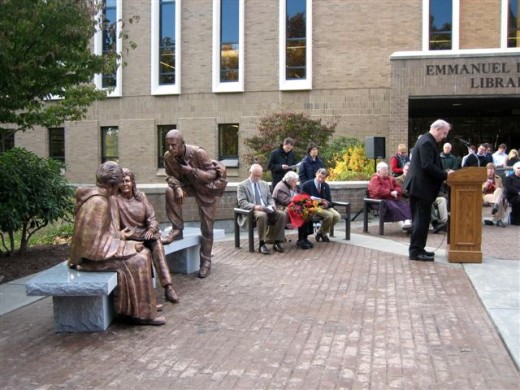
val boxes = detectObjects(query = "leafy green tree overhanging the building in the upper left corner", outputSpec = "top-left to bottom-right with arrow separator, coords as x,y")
0,0 -> 137,152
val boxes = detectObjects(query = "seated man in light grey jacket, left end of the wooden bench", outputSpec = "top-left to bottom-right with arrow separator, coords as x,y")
237,164 -> 286,255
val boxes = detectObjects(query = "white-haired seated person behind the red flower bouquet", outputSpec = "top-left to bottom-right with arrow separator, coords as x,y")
273,171 -> 314,249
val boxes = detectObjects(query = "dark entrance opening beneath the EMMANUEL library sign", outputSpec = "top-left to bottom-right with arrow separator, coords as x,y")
408,97 -> 520,156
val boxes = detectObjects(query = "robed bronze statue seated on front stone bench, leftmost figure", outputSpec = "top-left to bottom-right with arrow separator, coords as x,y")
68,161 -> 166,325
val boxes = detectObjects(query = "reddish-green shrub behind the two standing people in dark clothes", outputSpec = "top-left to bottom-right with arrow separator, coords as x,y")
243,112 -> 337,167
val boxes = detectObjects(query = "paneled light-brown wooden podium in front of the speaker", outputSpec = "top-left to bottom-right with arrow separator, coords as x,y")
448,167 -> 487,263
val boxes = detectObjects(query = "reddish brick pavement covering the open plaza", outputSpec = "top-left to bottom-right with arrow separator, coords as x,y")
0,227 -> 519,390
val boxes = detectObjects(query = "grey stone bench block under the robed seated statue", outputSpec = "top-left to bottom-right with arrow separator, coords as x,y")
25,261 -> 117,332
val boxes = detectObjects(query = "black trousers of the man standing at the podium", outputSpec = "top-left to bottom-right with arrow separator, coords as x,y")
408,196 -> 433,257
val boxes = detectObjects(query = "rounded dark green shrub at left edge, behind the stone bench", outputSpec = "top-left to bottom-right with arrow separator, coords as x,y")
0,148 -> 74,255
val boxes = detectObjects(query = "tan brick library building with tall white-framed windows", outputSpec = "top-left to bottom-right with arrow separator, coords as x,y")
15,0 -> 520,184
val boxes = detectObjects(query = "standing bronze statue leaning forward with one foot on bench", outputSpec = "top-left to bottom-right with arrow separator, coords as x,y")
161,130 -> 227,278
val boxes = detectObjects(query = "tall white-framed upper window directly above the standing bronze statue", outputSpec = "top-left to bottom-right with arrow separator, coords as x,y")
151,0 -> 181,95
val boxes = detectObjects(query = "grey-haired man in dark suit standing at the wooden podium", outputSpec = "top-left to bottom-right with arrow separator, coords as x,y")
405,119 -> 453,261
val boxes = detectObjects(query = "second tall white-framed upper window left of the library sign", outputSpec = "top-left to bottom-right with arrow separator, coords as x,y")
213,0 -> 244,92
